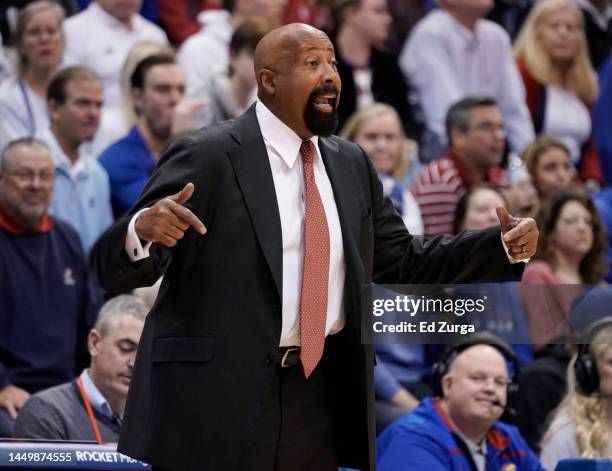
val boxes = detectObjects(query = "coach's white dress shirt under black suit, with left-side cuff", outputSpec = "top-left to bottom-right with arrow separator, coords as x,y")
125,102 -> 346,347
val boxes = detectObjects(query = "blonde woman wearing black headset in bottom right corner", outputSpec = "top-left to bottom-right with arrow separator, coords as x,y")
540,317 -> 612,471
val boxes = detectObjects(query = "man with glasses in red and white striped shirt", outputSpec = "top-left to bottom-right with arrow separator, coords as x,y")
412,97 -> 508,237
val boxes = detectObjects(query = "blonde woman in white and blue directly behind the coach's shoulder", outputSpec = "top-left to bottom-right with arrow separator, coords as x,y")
340,103 -> 423,234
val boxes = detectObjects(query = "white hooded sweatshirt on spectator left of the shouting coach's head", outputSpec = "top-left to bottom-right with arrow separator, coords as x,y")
178,10 -> 233,97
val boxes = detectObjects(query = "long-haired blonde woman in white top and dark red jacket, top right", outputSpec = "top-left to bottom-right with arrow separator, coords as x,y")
514,0 -> 602,189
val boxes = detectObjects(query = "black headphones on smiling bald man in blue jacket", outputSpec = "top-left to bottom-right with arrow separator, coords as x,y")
431,330 -> 520,403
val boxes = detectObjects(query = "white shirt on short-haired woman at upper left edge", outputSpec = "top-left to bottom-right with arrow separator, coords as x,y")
0,79 -> 49,149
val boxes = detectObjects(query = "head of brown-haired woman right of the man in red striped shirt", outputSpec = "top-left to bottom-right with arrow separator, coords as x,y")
523,135 -> 576,203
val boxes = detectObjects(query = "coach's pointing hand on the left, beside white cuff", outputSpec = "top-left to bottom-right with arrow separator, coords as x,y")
134,183 -> 206,247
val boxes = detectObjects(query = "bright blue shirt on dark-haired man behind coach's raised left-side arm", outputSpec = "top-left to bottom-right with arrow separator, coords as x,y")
98,126 -> 157,216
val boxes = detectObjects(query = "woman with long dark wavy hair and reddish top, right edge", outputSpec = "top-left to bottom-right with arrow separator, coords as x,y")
521,187 -> 607,346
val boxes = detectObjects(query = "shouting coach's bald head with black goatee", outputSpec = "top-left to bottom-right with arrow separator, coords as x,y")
254,23 -> 341,139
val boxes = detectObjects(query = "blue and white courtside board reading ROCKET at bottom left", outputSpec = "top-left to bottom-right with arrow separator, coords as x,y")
0,440 -> 151,470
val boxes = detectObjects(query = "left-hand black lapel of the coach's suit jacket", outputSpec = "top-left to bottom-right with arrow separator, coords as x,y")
229,105 -> 283,299
